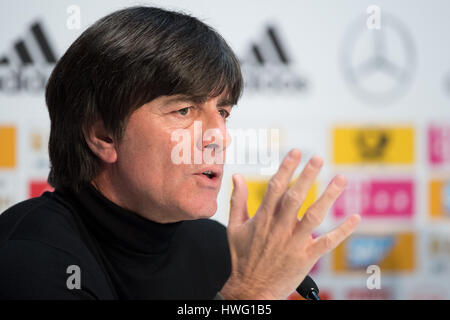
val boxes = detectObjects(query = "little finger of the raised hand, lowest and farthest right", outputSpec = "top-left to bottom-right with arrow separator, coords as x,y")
310,214 -> 361,259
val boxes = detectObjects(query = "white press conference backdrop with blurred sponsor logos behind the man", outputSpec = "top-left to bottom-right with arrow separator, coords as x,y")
0,0 -> 450,299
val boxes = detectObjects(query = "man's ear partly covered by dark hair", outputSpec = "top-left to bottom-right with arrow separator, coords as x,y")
84,120 -> 117,164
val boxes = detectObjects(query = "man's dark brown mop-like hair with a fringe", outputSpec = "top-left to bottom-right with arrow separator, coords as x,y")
46,6 -> 243,190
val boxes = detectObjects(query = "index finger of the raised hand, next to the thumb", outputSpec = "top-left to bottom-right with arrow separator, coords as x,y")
261,149 -> 301,213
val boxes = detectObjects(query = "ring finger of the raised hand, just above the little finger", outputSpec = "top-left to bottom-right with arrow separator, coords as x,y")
296,175 -> 347,236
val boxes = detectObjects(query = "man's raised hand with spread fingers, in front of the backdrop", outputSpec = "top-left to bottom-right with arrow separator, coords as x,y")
221,149 -> 360,299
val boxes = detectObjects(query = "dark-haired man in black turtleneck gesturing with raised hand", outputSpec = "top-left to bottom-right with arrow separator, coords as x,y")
0,7 -> 359,299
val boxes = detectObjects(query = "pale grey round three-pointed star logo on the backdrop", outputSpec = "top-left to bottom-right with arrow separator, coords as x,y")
340,12 -> 416,104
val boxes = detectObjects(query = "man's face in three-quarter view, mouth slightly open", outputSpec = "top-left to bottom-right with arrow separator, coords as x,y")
112,92 -> 231,223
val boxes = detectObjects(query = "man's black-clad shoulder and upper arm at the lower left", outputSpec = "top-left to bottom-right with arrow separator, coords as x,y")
0,192 -> 113,299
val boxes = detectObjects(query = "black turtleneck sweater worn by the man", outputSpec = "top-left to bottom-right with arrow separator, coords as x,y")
0,185 -> 231,299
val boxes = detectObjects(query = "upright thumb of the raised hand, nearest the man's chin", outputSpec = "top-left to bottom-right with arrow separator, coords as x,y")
228,174 -> 249,227
